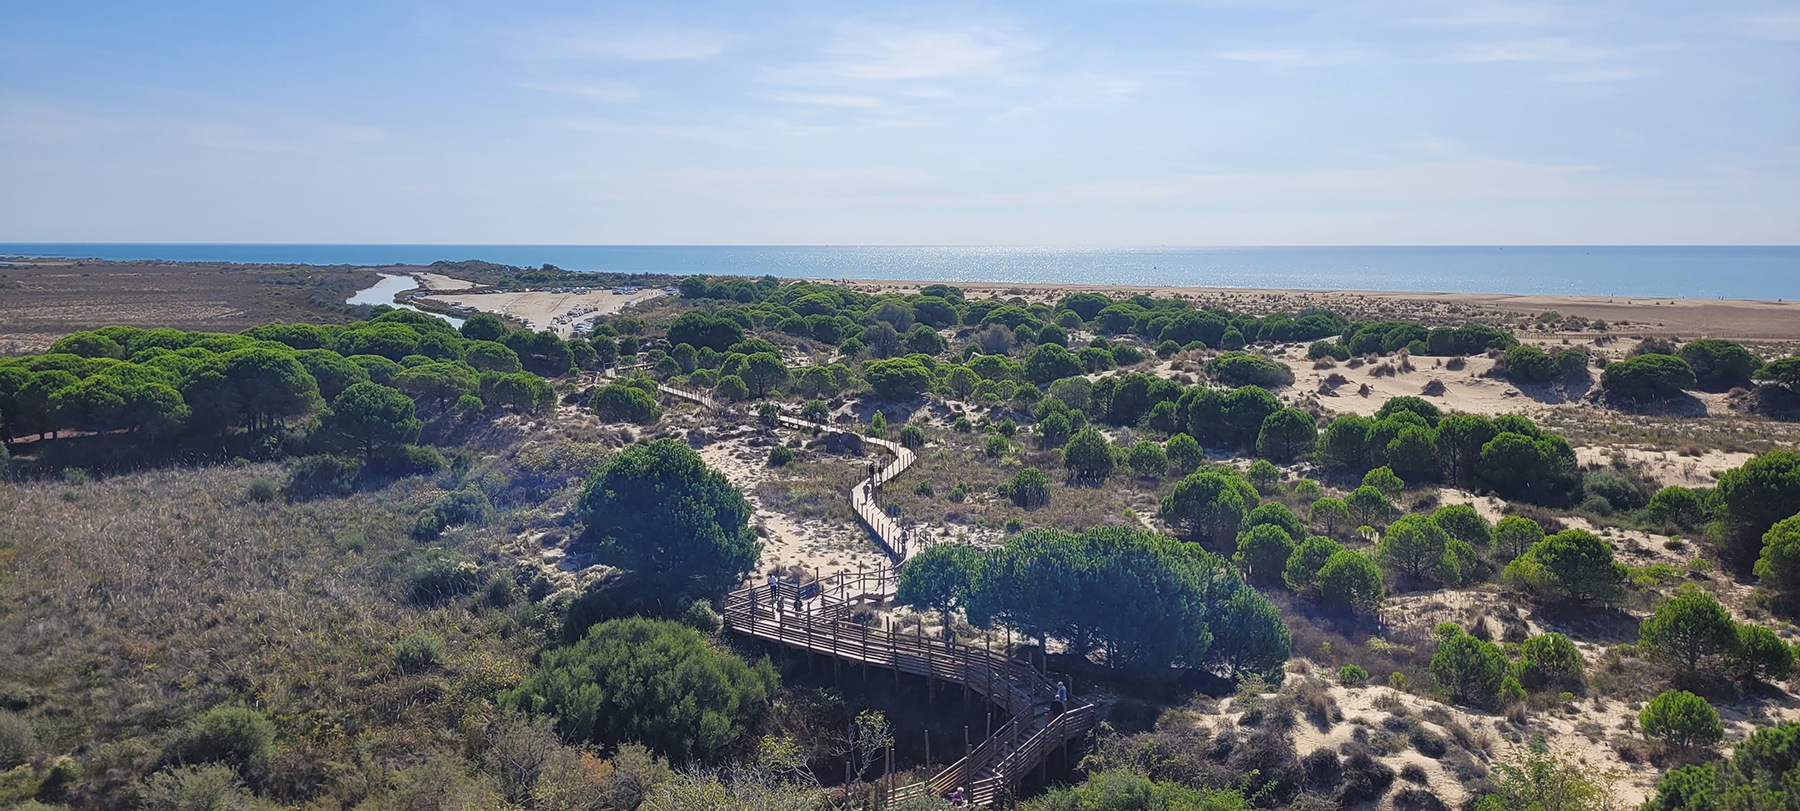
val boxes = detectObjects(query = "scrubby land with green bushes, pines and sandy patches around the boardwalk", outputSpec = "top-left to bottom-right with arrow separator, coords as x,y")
0,268 -> 1800,811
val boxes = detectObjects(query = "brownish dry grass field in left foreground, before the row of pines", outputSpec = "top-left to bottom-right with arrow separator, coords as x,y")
0,466 -> 544,807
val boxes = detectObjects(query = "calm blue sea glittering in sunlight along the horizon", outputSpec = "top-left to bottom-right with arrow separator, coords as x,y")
0,243 -> 1800,300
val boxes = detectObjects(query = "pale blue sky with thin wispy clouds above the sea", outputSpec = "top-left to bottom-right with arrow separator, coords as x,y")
0,0 -> 1800,245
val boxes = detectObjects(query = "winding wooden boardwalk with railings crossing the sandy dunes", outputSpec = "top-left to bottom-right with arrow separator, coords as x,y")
633,372 -> 1098,806
